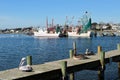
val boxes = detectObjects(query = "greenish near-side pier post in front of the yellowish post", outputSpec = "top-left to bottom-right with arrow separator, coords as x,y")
98,51 -> 105,80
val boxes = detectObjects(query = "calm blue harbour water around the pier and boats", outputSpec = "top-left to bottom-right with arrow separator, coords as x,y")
0,34 -> 120,80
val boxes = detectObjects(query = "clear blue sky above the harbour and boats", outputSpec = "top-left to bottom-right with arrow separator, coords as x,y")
0,0 -> 120,29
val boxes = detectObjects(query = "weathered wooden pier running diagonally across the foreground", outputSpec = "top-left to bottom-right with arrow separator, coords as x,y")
0,45 -> 120,80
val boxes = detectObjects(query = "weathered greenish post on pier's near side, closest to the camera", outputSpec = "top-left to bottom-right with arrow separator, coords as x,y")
61,61 -> 68,80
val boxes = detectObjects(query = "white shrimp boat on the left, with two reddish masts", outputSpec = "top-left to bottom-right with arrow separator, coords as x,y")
34,18 -> 68,37
